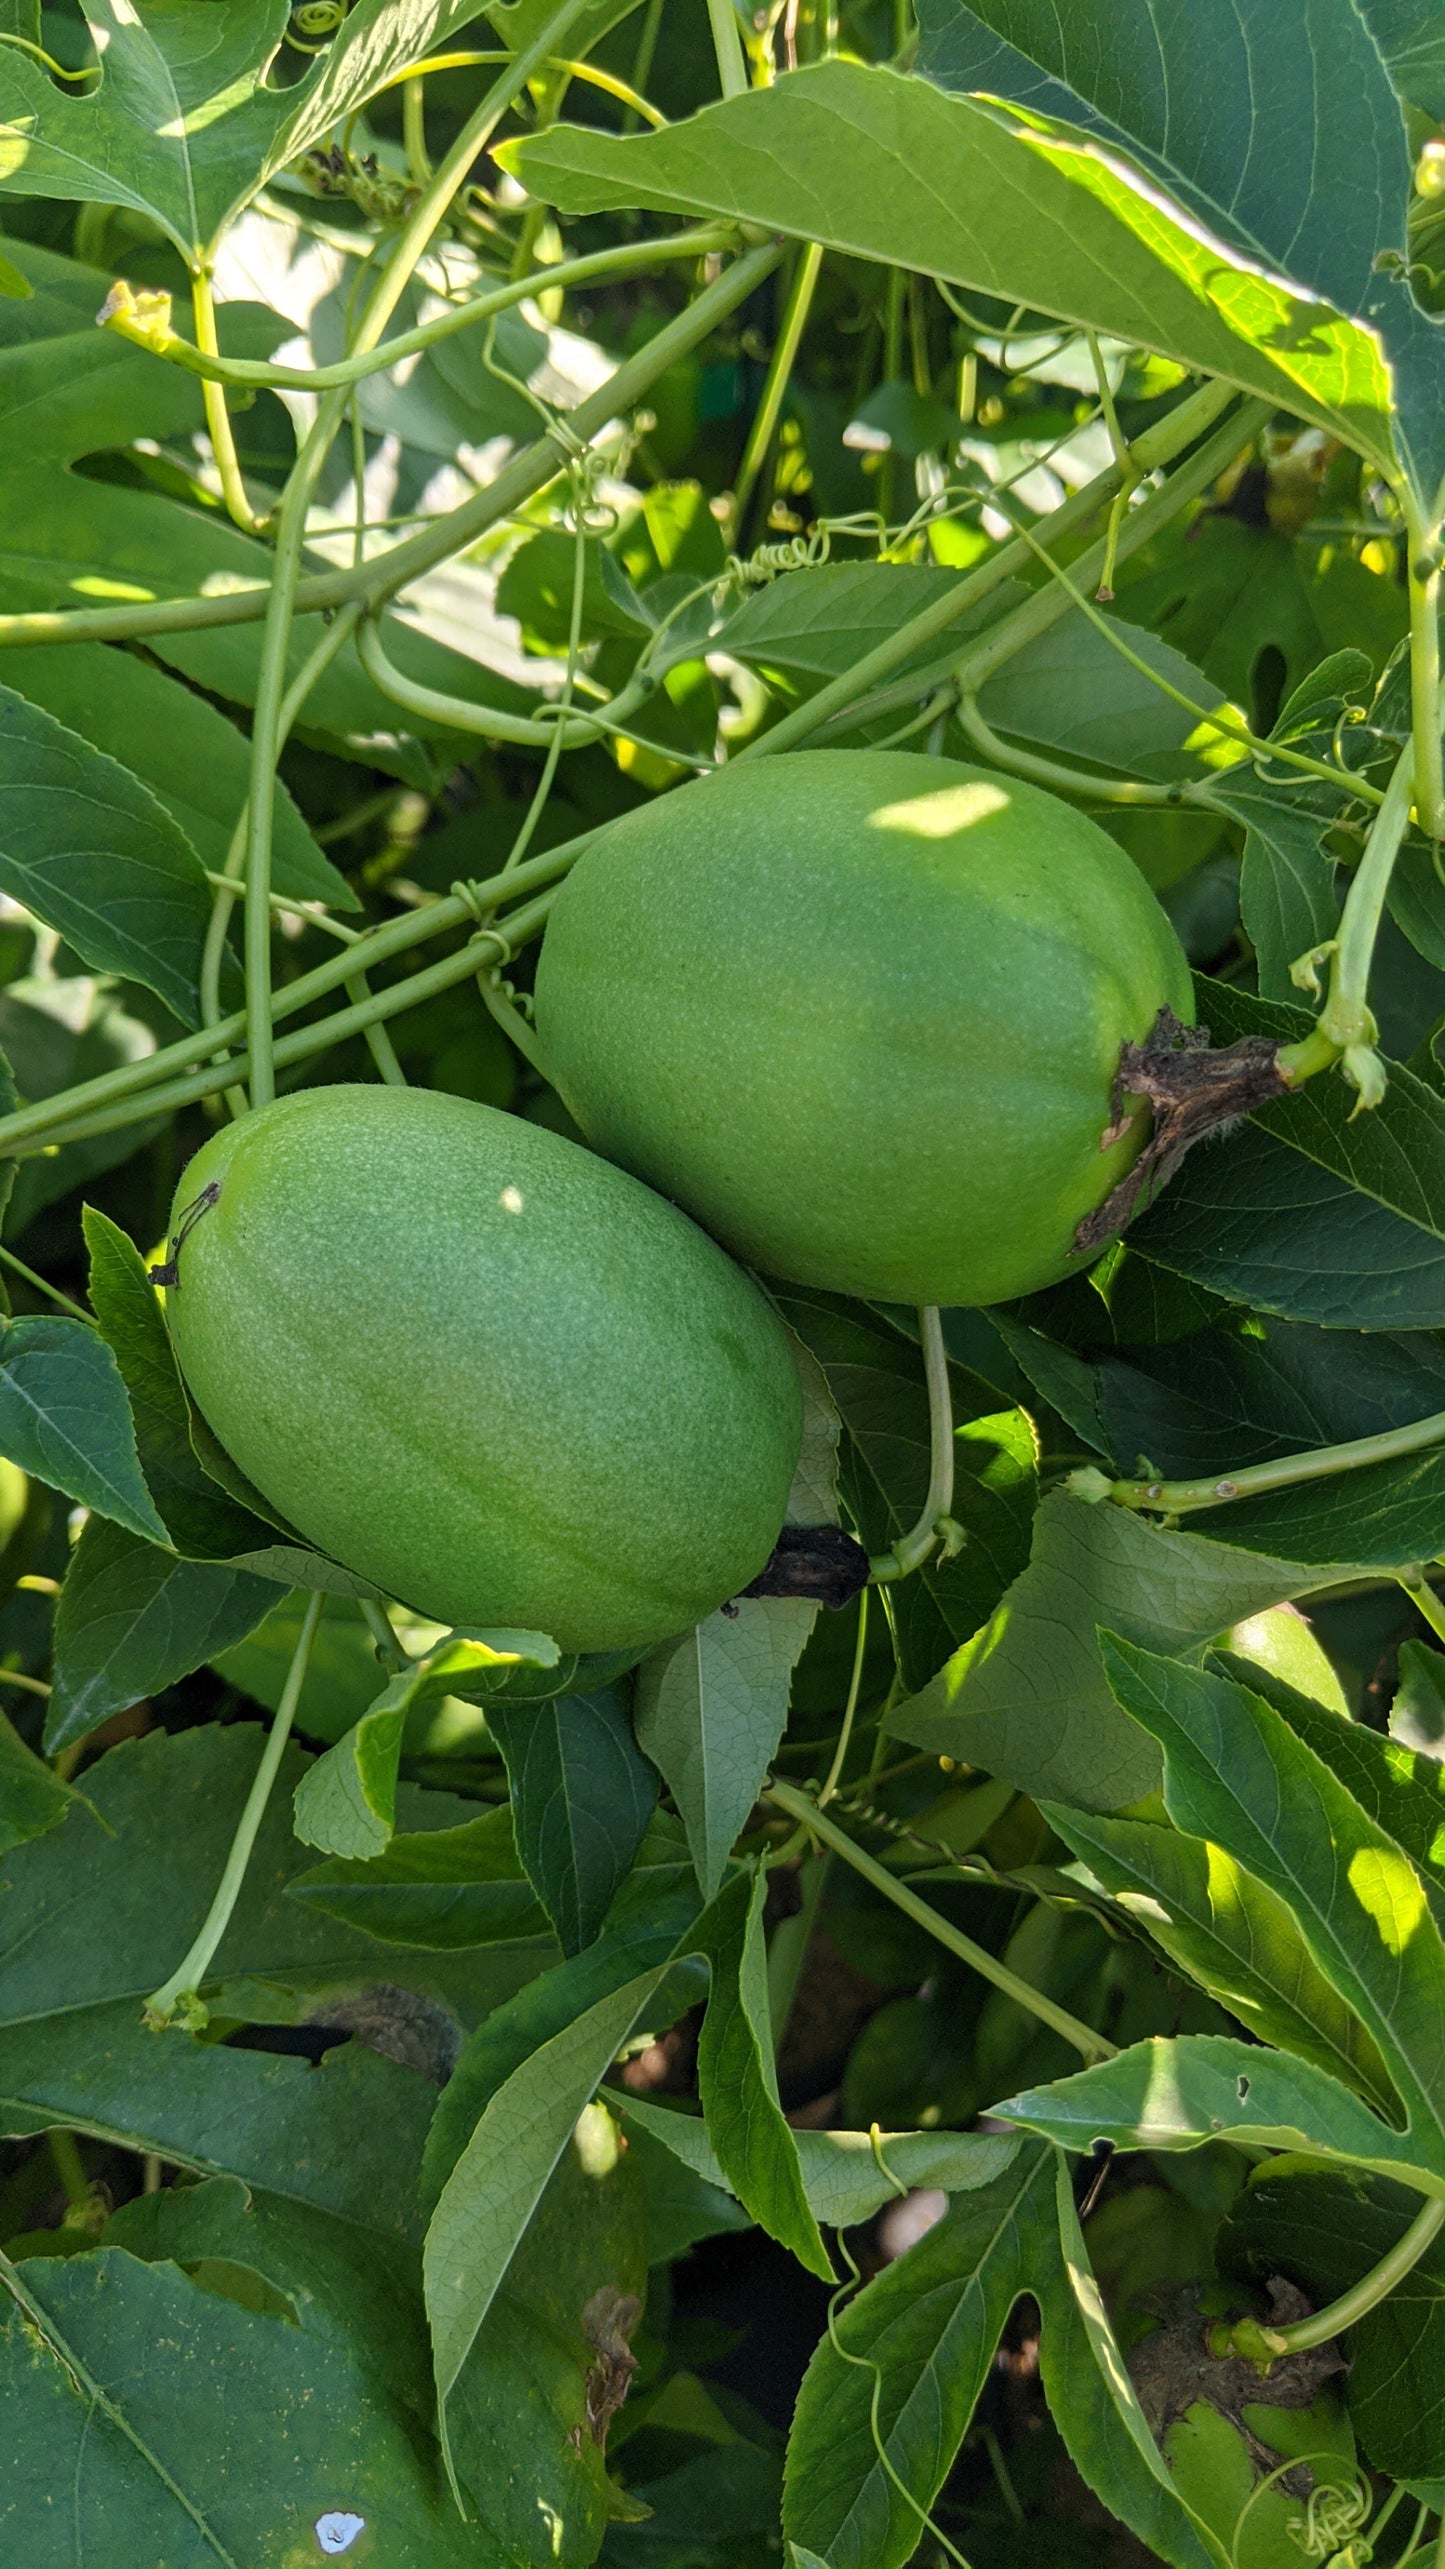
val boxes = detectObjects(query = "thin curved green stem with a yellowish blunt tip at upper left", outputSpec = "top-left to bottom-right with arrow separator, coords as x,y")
105,227 -> 738,393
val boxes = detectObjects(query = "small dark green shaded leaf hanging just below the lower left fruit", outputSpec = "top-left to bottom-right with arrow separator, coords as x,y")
489,1688 -> 658,1952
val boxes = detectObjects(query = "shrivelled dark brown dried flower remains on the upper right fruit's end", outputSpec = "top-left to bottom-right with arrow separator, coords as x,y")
1075,1007 -> 1293,1256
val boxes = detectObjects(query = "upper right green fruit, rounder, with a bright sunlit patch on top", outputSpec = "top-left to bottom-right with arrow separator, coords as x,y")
537,750 -> 1193,1302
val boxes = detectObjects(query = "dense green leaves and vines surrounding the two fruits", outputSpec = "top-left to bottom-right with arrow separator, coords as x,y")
0,0 -> 1445,2569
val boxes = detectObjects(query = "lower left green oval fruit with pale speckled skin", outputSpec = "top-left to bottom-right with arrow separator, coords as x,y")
167,1087 -> 802,1649
